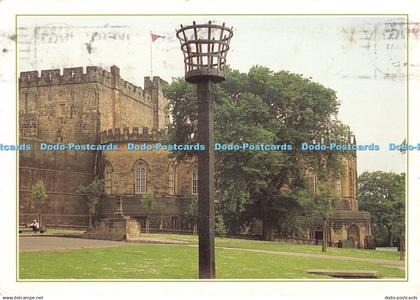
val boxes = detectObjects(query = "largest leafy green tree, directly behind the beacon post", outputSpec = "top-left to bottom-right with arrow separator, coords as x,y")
165,66 -> 349,240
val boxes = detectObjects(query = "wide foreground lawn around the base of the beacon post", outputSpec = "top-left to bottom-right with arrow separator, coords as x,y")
19,244 -> 404,279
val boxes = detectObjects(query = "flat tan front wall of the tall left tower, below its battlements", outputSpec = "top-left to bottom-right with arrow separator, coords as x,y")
19,83 -> 99,143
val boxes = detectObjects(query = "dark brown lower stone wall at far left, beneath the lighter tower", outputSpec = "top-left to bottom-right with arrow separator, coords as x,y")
19,138 -> 96,226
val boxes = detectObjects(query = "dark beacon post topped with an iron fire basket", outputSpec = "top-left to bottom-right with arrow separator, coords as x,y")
176,22 -> 233,279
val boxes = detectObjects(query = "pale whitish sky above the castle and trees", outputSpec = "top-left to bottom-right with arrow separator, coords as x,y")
18,16 -> 407,173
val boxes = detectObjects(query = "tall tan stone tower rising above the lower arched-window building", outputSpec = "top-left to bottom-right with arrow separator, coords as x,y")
19,66 -> 169,143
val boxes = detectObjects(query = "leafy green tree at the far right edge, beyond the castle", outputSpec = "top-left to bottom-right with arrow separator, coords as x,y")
358,171 -> 405,247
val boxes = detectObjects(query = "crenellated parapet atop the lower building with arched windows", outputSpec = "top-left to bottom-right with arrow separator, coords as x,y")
100,127 -> 167,144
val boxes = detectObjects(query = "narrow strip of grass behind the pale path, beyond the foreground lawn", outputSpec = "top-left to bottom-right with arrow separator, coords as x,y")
148,234 -> 400,260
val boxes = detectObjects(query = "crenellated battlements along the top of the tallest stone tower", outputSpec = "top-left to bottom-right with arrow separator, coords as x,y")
19,66 -> 167,105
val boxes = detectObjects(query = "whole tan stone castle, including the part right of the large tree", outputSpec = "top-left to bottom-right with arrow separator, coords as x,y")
19,66 -> 370,247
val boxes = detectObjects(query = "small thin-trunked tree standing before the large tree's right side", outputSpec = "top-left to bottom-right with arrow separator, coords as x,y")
299,183 -> 339,252
